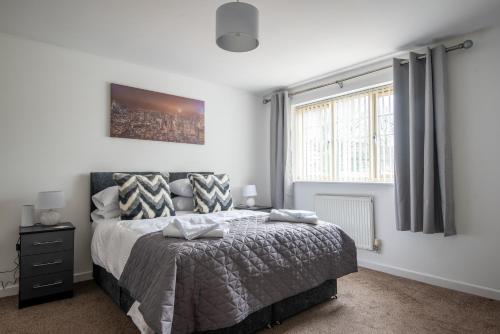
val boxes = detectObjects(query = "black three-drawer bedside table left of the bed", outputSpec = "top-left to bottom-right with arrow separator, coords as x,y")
18,223 -> 75,308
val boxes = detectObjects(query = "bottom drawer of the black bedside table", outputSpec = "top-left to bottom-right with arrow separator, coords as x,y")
19,271 -> 73,301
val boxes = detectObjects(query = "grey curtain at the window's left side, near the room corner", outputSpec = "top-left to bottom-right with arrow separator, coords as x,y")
271,91 -> 293,209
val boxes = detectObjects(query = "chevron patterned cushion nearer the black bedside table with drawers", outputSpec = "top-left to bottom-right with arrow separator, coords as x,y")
113,173 -> 175,220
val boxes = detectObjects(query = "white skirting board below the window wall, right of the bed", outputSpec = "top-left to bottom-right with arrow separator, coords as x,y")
358,259 -> 500,300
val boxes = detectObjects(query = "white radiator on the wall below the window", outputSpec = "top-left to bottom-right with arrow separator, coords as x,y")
314,195 -> 375,250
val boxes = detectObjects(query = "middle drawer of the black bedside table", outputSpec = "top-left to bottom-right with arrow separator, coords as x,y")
21,250 -> 73,278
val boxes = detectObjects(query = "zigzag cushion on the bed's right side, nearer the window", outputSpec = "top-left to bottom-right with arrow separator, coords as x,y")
188,174 -> 233,213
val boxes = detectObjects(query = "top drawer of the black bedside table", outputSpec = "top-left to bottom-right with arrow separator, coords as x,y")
21,231 -> 73,256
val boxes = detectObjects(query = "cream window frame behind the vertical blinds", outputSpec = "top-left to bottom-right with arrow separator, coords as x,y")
291,81 -> 394,185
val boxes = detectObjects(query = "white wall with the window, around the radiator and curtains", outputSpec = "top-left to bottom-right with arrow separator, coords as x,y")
295,28 -> 500,299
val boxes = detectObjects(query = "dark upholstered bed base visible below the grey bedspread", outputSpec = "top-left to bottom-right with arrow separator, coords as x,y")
93,264 -> 337,334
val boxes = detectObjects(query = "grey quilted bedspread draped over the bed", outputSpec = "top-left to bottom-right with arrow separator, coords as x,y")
119,216 -> 357,334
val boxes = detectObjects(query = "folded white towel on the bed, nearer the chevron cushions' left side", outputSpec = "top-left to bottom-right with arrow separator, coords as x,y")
163,215 -> 229,240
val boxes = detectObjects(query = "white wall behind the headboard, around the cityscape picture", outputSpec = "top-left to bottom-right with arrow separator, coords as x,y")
0,35 -> 269,295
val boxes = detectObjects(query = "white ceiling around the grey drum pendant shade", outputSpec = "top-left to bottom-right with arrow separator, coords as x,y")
0,0 -> 500,93
